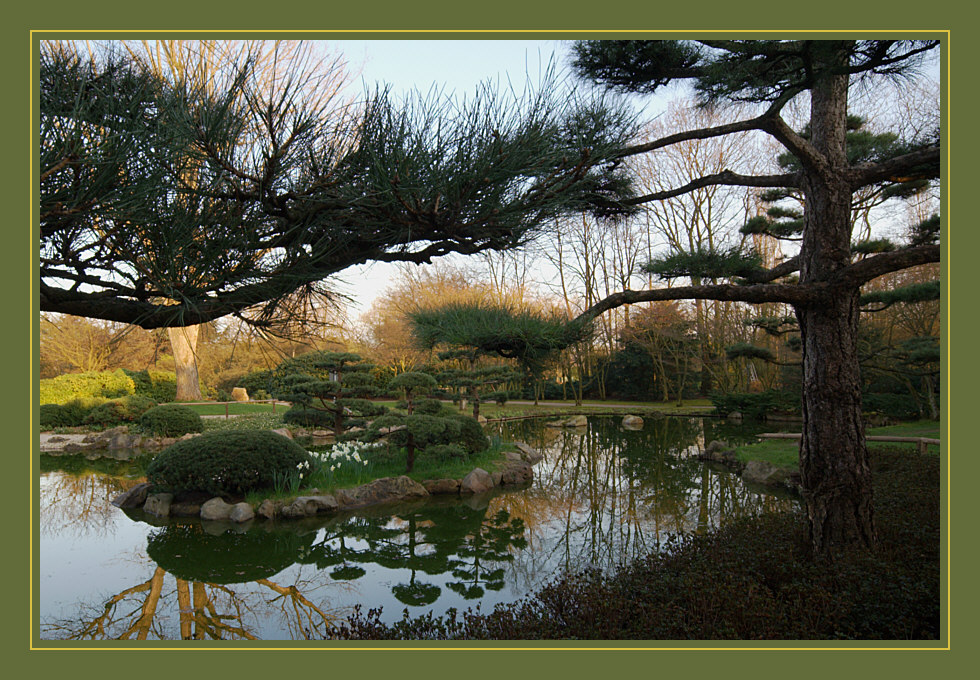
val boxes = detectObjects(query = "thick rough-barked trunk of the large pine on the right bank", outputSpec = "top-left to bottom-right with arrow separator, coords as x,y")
796,41 -> 876,556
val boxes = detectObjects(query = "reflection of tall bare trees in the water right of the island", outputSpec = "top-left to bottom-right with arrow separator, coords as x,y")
482,417 -> 796,590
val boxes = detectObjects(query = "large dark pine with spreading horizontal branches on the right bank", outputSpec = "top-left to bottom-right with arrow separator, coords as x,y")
575,40 -> 940,555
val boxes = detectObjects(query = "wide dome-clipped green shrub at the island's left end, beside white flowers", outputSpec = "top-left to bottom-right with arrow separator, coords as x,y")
146,430 -> 310,496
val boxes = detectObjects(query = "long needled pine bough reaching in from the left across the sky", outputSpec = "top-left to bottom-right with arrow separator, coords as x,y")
39,45 -> 633,328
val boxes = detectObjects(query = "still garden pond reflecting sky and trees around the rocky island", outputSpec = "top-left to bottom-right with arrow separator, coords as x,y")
39,417 -> 797,640
